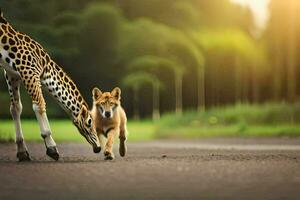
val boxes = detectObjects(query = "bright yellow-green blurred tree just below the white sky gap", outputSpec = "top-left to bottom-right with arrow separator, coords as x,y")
191,29 -> 268,105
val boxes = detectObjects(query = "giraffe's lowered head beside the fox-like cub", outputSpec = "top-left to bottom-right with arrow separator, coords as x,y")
73,105 -> 101,153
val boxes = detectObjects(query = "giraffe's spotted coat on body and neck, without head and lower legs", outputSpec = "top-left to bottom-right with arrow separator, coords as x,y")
0,16 -> 87,117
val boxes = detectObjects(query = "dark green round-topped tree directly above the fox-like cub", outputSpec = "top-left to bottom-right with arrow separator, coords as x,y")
72,3 -> 123,98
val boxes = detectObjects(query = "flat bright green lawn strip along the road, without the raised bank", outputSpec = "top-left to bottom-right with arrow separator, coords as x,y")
0,120 -> 300,142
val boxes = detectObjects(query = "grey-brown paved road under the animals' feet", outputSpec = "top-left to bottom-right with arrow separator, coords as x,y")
0,138 -> 300,200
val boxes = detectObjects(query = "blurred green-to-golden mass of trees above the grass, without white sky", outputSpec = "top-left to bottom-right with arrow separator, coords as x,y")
0,0 -> 300,118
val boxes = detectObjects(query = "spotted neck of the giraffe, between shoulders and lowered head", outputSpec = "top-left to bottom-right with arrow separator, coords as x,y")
42,61 -> 88,119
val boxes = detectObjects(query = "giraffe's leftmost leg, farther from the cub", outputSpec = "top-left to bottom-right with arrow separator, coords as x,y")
4,72 -> 31,161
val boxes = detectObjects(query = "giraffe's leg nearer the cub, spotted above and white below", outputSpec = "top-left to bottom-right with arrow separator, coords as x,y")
25,76 -> 59,160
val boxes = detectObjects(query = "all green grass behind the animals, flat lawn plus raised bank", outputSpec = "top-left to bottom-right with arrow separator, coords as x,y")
0,104 -> 300,142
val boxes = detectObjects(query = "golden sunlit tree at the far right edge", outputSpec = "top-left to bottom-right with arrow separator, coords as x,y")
264,0 -> 300,102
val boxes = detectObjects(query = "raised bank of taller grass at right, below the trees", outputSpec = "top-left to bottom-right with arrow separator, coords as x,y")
158,103 -> 300,127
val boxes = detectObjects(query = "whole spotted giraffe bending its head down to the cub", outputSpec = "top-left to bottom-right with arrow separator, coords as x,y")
0,9 -> 101,161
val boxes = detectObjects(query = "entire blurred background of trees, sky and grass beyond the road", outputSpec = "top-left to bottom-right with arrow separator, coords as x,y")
0,0 -> 300,140
